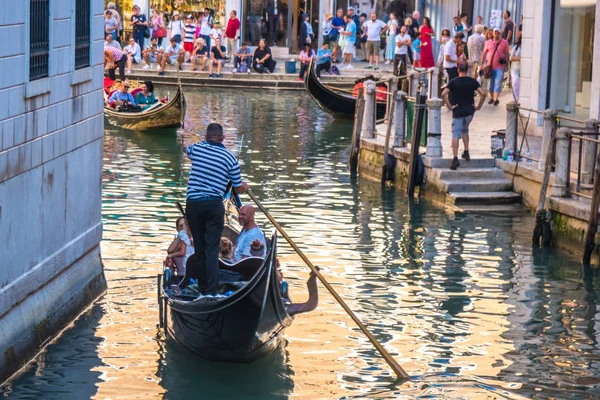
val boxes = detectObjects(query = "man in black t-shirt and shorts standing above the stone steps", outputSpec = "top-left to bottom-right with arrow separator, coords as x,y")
442,63 -> 485,170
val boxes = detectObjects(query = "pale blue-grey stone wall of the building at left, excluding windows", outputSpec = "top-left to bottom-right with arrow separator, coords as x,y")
0,0 -> 106,382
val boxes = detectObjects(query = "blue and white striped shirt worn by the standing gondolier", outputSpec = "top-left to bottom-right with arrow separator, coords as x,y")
185,141 -> 242,200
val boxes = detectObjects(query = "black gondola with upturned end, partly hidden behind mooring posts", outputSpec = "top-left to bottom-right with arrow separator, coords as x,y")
304,62 -> 386,119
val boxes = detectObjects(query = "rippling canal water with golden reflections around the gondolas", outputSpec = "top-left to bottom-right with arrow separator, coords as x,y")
0,88 -> 600,399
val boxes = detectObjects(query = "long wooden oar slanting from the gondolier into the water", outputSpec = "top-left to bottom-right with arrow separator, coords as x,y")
246,189 -> 410,379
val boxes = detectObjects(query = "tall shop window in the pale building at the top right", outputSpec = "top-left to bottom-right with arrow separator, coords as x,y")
548,0 -> 596,118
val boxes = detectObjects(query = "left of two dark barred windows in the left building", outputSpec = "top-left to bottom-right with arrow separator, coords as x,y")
29,0 -> 50,81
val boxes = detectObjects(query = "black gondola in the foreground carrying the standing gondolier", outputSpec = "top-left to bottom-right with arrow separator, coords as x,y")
159,192 -> 318,363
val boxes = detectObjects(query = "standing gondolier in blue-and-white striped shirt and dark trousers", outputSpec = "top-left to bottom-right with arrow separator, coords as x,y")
186,123 -> 248,296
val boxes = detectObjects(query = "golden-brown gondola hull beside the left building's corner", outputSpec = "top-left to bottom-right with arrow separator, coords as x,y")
104,83 -> 185,131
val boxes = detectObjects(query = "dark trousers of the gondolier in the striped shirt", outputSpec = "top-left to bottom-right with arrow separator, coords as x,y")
186,198 -> 225,295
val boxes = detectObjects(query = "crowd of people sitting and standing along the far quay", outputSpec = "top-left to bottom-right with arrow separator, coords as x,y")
105,3 -> 522,100
